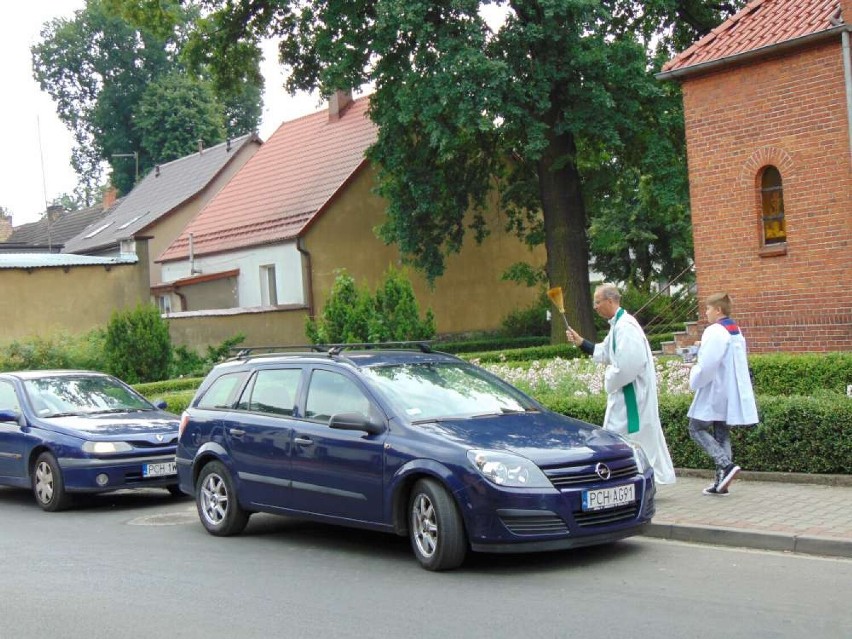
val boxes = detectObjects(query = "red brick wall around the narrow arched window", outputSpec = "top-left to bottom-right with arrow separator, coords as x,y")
683,36 -> 852,352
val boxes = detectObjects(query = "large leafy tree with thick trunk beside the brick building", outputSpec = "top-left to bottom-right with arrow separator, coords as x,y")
115,0 -> 742,336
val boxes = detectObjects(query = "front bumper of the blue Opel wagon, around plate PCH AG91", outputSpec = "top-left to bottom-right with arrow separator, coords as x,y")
457,472 -> 656,552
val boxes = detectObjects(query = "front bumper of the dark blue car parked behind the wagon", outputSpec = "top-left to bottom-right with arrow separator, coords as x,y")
57,454 -> 178,493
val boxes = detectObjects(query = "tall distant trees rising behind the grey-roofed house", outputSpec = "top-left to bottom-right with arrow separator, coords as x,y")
32,0 -> 262,200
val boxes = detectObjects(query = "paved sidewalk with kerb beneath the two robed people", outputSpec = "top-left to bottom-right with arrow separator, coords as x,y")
646,470 -> 852,558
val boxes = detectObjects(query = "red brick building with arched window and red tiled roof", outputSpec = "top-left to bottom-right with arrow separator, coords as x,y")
658,0 -> 852,352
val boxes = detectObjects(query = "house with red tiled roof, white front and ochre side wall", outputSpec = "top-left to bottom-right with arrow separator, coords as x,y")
152,92 -> 544,346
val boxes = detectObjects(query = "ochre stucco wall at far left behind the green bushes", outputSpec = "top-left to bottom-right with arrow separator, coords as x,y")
0,264 -> 149,342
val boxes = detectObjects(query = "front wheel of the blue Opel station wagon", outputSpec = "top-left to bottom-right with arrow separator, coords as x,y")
408,479 -> 467,571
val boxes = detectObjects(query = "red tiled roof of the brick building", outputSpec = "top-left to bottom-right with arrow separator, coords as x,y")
663,0 -> 849,74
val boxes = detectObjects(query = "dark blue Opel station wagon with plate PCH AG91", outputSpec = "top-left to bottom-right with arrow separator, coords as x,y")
177,344 -> 655,570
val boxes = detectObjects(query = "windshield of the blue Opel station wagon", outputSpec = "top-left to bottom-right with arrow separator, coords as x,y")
364,363 -> 538,423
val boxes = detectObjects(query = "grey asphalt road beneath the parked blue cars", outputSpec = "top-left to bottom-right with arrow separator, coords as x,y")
0,488 -> 852,639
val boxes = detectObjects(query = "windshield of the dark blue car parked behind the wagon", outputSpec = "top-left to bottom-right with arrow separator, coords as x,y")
24,375 -> 154,417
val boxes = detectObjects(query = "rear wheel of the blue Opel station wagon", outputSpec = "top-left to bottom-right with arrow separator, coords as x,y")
195,461 -> 251,537
